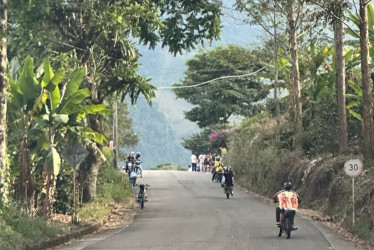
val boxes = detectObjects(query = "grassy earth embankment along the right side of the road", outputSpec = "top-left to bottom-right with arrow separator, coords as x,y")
224,116 -> 374,246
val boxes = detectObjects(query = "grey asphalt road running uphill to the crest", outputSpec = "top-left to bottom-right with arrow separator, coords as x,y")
59,171 -> 360,250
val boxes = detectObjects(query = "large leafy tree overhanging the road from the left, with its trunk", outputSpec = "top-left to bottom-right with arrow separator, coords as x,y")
11,0 -> 224,201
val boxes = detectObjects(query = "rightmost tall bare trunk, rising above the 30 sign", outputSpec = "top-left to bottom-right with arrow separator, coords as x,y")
360,0 -> 374,159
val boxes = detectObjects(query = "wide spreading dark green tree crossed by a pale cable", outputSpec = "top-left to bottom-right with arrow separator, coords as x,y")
173,45 -> 268,128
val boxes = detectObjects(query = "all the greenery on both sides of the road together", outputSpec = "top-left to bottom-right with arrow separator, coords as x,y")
0,0 -> 374,249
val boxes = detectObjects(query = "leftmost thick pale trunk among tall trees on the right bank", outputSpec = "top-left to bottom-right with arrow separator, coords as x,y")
287,7 -> 303,133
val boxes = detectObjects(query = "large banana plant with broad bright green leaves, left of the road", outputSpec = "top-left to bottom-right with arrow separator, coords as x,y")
9,57 -> 111,216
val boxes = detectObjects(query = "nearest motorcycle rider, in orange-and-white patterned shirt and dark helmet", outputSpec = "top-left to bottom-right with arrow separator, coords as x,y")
273,182 -> 300,230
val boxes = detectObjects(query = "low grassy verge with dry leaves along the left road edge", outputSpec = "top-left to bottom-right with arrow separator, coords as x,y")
0,147 -> 134,250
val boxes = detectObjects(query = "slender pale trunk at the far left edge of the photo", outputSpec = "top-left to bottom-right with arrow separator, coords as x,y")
0,0 -> 8,200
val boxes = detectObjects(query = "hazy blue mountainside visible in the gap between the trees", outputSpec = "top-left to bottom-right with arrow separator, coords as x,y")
129,0 -> 262,166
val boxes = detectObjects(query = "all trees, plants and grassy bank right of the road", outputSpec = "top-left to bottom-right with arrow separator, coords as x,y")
174,0 -> 374,244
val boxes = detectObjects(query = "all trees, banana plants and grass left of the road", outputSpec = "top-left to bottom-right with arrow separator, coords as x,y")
0,0 -> 221,249
